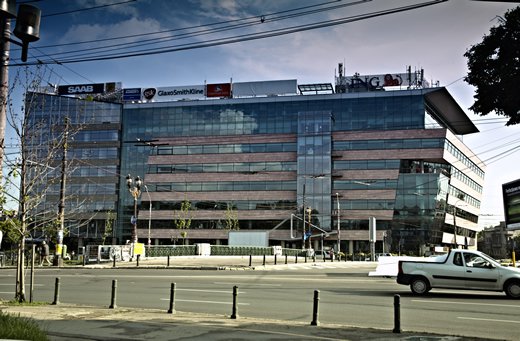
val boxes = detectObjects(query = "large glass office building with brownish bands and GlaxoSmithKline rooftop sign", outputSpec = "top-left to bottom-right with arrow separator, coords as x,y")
27,67 -> 485,254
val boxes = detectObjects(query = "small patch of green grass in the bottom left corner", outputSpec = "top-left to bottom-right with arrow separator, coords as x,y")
0,311 -> 49,341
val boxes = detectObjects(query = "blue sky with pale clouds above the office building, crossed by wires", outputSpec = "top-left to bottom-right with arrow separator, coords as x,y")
7,0 -> 520,226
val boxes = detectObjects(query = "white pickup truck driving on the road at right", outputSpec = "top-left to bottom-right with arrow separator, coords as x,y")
397,249 -> 520,298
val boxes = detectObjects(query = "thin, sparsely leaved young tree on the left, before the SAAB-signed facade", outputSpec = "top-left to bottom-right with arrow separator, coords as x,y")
3,68 -> 85,302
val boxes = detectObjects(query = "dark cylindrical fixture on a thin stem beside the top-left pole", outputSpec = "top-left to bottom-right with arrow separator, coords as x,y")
13,4 -> 41,62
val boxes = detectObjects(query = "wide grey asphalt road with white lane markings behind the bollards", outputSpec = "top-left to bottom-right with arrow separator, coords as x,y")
0,265 -> 520,340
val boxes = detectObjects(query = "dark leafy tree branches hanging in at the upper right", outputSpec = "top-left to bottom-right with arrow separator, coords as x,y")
464,6 -> 520,125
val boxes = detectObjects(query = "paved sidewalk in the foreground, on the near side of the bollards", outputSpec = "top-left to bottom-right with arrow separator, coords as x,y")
0,304 -> 486,341
